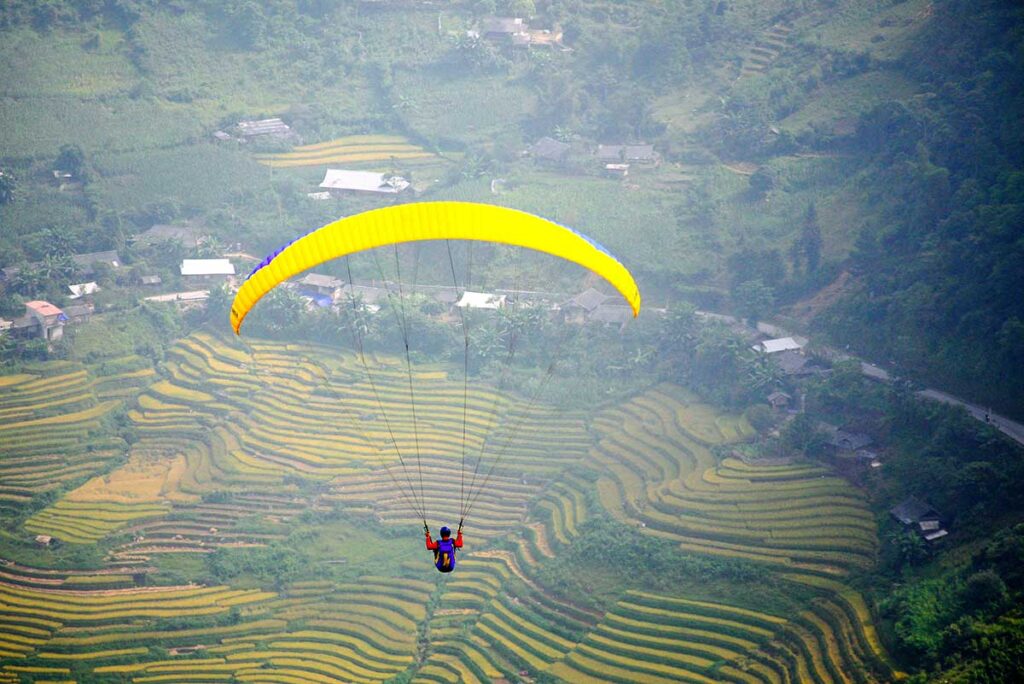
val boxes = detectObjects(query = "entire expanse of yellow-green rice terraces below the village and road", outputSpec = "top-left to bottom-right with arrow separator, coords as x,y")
0,333 -> 893,684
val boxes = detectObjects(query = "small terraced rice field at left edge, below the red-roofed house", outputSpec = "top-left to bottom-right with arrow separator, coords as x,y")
0,361 -> 130,508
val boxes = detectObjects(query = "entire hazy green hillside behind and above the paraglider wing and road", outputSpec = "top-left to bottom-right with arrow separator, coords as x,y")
0,0 -> 1024,417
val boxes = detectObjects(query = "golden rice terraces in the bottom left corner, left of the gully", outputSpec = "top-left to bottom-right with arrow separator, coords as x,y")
0,557 -> 425,682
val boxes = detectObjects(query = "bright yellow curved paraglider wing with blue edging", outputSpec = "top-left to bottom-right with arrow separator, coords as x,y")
231,202 -> 640,334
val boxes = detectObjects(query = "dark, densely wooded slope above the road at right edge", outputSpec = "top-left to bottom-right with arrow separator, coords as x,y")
824,0 -> 1024,416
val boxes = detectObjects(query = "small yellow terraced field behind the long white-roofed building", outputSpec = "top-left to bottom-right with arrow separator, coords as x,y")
256,135 -> 436,168
